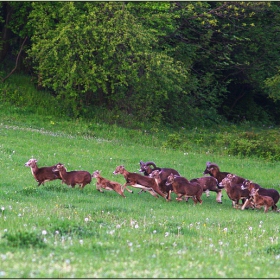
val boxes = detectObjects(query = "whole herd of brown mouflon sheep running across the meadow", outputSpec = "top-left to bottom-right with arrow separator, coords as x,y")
25,158 -> 279,212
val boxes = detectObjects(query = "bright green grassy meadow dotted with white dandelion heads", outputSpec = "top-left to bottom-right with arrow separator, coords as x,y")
0,107 -> 280,278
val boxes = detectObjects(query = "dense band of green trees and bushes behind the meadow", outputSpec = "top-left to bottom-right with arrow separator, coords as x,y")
0,1 -> 280,127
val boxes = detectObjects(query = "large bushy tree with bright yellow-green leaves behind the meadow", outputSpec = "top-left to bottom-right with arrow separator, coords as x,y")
29,2 -> 187,121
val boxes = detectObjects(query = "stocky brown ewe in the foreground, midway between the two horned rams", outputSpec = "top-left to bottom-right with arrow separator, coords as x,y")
166,173 -> 203,204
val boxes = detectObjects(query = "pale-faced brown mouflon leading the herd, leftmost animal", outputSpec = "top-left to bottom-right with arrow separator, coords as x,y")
25,158 -> 61,187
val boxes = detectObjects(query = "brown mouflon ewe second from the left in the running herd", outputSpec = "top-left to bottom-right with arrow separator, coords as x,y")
53,163 -> 91,188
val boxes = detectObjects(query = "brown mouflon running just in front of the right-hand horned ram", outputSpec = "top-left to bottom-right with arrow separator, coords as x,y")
219,173 -> 250,208
